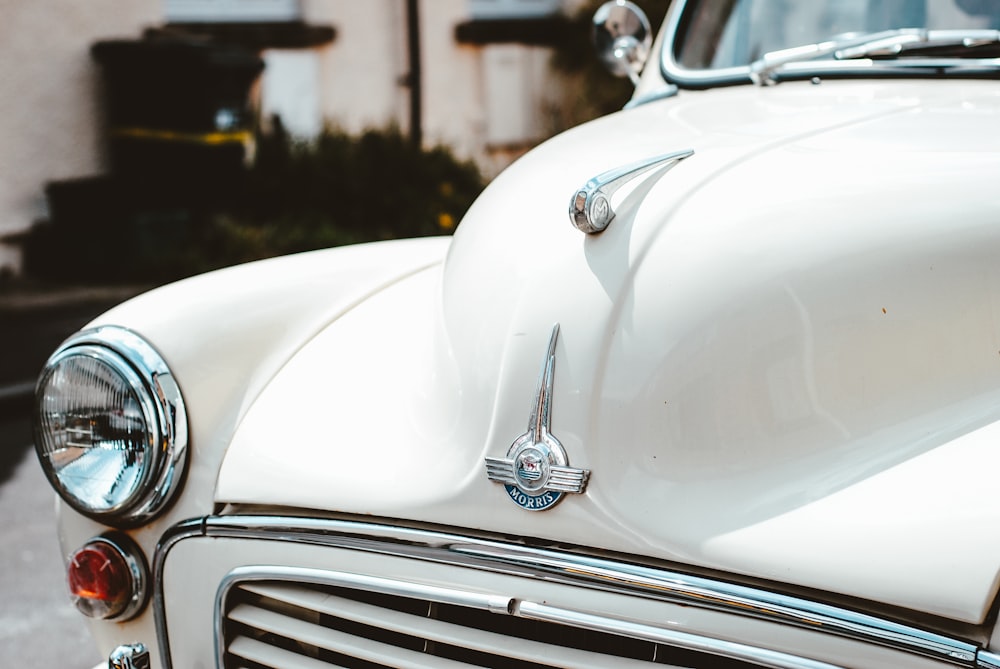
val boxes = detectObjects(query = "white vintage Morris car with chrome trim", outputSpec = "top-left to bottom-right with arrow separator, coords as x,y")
36,0 -> 1000,669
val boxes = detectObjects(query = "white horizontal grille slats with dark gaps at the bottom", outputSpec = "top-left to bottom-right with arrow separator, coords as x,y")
223,581 -> 758,669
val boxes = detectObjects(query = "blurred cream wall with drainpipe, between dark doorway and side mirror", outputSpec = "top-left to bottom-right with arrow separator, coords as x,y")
254,0 -> 578,173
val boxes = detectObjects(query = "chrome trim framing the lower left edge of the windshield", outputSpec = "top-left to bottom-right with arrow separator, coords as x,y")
659,0 -> 1000,89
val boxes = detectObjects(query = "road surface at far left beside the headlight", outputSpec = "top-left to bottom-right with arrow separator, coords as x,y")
0,283 -> 146,669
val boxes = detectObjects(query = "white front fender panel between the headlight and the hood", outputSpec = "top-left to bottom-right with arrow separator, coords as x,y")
84,238 -> 450,528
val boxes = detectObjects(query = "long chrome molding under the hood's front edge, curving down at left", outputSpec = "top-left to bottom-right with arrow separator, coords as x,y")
153,516 -> 988,669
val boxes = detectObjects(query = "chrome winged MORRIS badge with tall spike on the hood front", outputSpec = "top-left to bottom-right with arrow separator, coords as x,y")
486,323 -> 590,511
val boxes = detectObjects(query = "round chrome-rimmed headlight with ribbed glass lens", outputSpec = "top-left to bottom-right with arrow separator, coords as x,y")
35,327 -> 187,525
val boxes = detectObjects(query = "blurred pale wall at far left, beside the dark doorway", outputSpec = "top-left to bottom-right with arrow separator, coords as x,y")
0,0 -> 161,272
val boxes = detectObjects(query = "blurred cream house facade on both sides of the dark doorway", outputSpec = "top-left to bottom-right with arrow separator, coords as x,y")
0,0 -> 581,280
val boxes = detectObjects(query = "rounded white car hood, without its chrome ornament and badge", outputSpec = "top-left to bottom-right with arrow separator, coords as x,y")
216,82 -> 1000,623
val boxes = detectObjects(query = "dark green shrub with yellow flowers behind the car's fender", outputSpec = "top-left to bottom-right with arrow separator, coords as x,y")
213,129 -> 485,260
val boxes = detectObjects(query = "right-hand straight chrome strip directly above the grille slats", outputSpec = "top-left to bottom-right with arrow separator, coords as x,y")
515,602 -> 842,669
